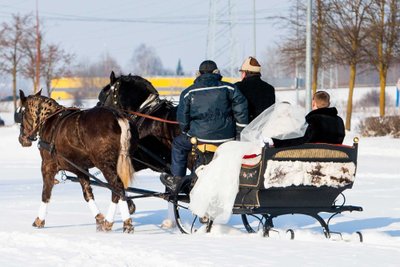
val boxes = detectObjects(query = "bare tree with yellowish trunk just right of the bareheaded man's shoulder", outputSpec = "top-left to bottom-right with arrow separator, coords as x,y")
327,0 -> 372,130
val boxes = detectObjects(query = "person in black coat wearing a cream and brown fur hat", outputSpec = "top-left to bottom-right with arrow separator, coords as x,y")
235,57 -> 275,123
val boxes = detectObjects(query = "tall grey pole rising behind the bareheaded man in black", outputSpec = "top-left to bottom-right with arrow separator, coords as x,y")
305,0 -> 312,111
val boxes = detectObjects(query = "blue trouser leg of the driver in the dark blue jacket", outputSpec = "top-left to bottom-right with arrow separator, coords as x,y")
171,134 -> 192,177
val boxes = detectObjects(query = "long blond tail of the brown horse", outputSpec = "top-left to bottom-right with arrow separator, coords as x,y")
117,118 -> 135,188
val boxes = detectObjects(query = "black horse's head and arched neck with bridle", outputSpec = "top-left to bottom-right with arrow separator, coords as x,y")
99,71 -> 158,111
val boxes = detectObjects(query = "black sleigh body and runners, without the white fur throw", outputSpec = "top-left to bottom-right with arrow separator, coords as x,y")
175,138 -> 363,241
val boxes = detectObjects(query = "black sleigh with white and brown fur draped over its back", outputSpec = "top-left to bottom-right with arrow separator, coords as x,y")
175,138 -> 363,242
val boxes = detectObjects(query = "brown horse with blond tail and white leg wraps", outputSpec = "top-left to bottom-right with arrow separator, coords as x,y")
19,91 -> 138,233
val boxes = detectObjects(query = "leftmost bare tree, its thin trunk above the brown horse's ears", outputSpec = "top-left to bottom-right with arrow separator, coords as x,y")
0,15 -> 32,109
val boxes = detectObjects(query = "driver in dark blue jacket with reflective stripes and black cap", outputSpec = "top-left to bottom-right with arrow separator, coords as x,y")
160,60 -> 248,192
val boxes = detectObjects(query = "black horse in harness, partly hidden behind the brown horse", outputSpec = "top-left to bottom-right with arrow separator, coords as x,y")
98,72 -> 180,172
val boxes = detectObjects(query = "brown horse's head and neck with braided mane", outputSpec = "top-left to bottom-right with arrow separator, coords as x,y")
17,90 -> 62,147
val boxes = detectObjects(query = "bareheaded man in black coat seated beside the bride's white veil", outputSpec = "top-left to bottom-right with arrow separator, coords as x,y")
270,91 -> 345,147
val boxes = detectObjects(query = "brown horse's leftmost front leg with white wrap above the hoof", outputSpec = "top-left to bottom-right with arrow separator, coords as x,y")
32,160 -> 57,228
